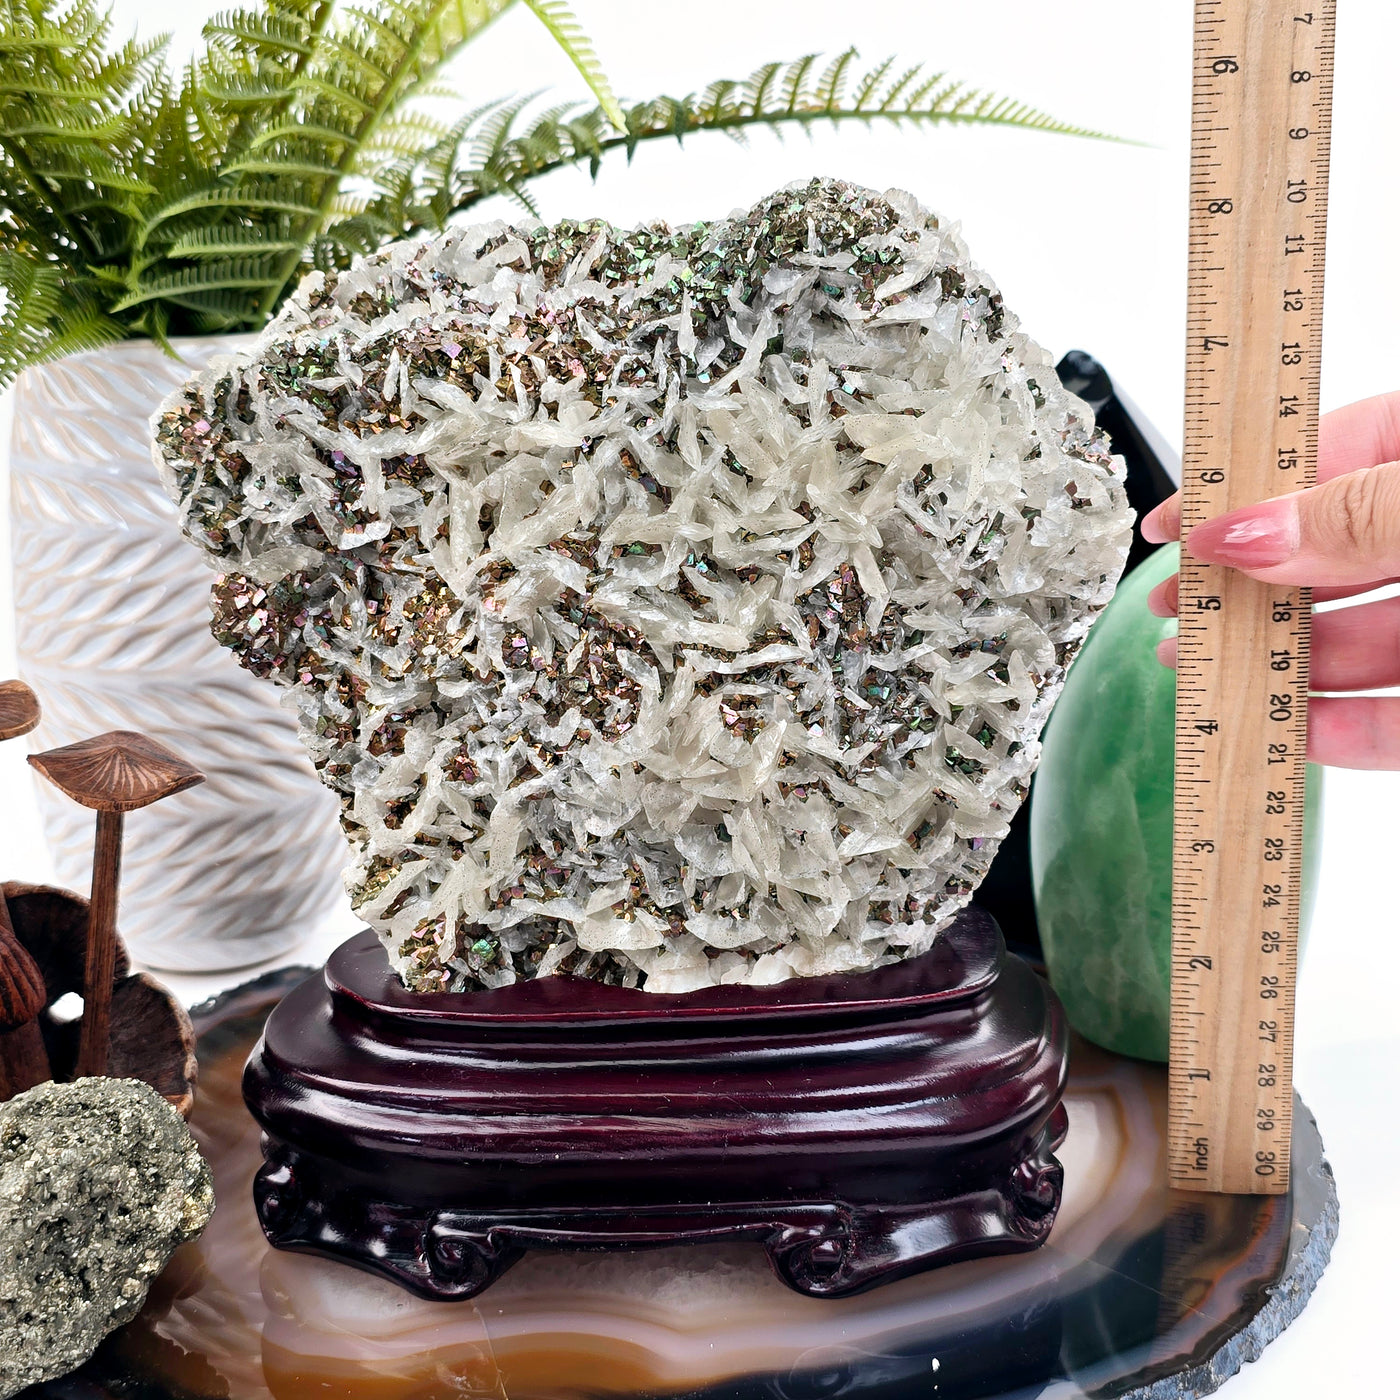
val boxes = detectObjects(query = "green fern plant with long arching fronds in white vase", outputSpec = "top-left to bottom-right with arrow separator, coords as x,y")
0,0 -> 1091,386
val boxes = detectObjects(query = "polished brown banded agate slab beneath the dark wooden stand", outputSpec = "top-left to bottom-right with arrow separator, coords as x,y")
65,970 -> 1336,1400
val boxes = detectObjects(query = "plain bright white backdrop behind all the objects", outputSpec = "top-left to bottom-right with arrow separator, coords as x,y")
0,0 -> 1400,1400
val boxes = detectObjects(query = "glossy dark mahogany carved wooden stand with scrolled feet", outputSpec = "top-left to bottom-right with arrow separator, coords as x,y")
244,909 -> 1067,1299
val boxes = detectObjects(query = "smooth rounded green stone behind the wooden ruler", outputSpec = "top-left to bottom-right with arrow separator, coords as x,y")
1030,545 -> 1322,1060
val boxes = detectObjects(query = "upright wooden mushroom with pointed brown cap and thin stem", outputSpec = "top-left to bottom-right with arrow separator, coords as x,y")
29,729 -> 204,1077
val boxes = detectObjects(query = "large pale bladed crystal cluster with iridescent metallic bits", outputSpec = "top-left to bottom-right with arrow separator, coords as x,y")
155,181 -> 1130,991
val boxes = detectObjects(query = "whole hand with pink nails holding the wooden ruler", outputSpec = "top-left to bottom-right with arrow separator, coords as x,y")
1142,392 -> 1400,769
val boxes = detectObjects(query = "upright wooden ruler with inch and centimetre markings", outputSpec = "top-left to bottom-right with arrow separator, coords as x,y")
1169,0 -> 1336,1194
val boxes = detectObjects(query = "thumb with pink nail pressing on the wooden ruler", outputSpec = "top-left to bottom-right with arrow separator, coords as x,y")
1186,462 -> 1400,585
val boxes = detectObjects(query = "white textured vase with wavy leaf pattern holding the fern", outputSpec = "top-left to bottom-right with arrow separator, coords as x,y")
10,337 -> 353,972
